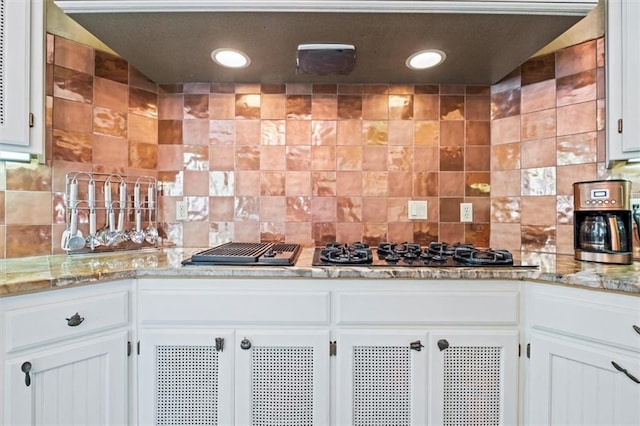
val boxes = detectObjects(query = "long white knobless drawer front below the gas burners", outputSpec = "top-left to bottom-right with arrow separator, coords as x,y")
336,291 -> 519,325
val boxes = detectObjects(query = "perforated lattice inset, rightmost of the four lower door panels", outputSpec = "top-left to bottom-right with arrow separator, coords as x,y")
443,346 -> 502,426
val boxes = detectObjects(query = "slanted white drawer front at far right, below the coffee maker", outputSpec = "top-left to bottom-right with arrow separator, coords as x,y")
531,292 -> 640,352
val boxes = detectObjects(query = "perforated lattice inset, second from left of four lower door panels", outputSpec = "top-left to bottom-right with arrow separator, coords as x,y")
251,346 -> 314,426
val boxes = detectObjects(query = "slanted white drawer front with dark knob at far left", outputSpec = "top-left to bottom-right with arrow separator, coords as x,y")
4,291 -> 129,352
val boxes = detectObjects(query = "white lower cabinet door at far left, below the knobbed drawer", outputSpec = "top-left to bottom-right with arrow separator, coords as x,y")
4,330 -> 129,426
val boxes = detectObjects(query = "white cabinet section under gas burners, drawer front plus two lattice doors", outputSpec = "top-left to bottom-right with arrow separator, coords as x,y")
334,281 -> 519,425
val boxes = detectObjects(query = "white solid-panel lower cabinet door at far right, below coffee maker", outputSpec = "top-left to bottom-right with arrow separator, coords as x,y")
528,331 -> 640,426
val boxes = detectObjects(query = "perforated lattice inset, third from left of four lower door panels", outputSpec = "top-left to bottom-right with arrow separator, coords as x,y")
353,346 -> 412,426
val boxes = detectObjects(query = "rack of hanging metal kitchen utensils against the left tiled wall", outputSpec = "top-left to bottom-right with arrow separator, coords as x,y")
61,172 -> 159,254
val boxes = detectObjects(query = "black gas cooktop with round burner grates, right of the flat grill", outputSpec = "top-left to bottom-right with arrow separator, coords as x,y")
313,242 -> 535,268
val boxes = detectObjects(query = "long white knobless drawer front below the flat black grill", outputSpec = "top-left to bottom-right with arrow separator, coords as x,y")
139,290 -> 330,324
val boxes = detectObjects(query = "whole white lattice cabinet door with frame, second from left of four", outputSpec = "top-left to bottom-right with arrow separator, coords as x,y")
235,330 -> 331,426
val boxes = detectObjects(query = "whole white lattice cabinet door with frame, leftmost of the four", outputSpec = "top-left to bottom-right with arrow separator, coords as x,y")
138,329 -> 234,426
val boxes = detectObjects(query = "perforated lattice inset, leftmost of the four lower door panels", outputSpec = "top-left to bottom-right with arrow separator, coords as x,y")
156,346 -> 219,426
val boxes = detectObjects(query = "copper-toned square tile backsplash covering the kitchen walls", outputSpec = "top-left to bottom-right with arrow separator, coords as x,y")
0,35 -> 638,258
